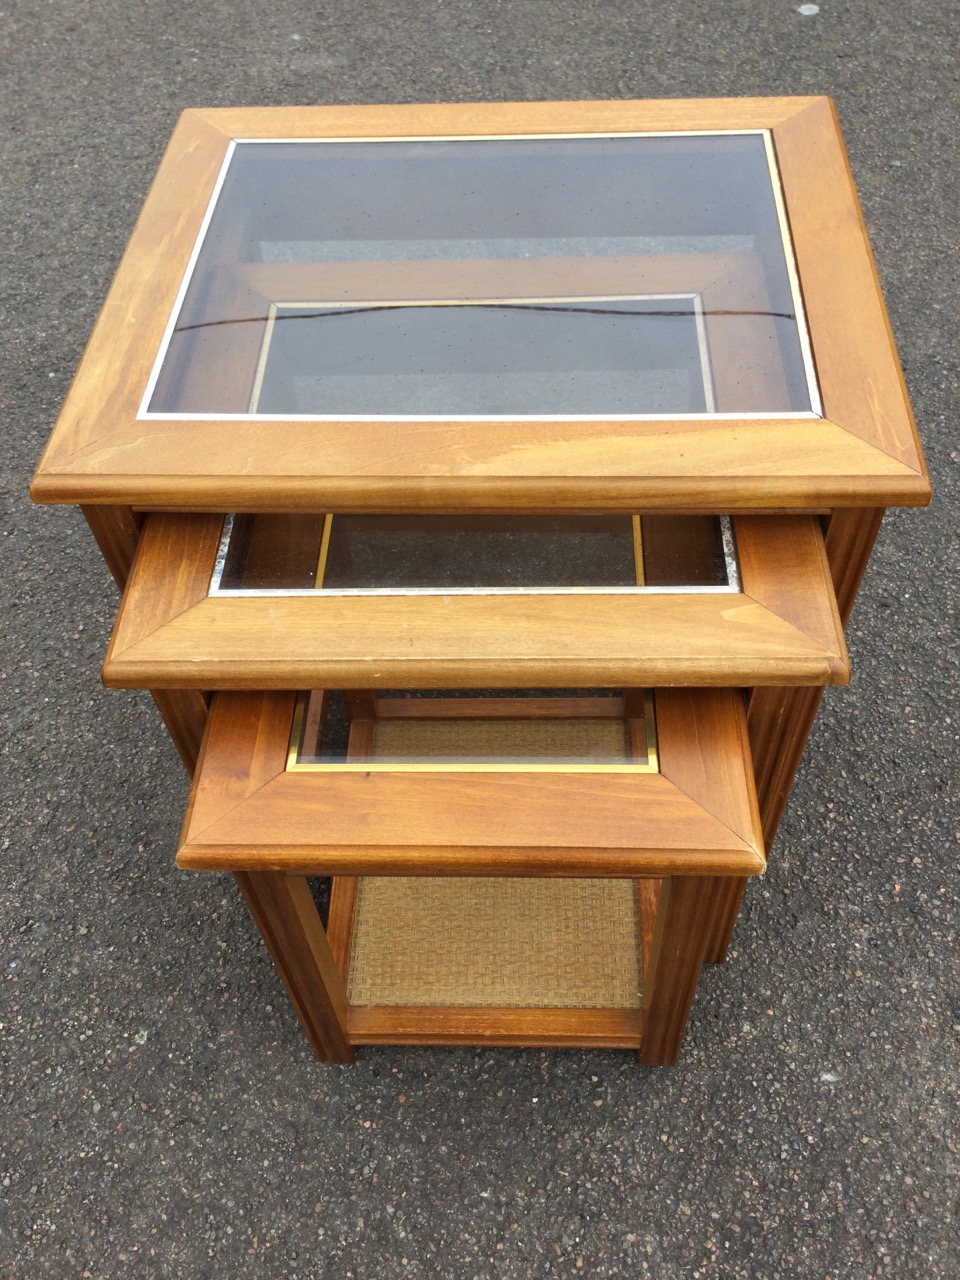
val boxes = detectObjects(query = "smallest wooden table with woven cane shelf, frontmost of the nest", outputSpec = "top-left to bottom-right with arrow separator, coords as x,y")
178,690 -> 764,1064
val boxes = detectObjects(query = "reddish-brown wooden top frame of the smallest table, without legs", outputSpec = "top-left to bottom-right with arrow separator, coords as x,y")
178,690 -> 764,877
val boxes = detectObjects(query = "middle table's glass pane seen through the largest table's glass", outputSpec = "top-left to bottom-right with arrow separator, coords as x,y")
251,297 -> 713,417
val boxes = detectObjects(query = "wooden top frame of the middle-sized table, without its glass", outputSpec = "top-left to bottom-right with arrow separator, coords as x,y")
104,515 -> 849,689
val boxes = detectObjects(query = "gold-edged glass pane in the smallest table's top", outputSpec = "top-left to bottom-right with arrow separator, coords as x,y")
288,690 -> 657,772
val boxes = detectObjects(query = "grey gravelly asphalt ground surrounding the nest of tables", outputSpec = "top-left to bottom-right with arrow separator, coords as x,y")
0,0 -> 960,1280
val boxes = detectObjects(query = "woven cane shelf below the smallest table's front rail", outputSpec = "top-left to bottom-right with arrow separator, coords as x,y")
348,877 -> 640,1009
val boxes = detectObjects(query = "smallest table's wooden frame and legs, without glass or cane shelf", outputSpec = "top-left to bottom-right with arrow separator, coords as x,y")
178,690 -> 765,1065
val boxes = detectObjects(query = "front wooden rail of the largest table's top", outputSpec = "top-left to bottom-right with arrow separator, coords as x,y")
31,419 -> 929,512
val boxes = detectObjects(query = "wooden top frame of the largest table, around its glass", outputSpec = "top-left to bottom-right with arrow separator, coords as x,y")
32,97 -> 929,511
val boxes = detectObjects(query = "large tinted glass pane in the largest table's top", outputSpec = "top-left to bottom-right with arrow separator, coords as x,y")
148,133 -> 818,420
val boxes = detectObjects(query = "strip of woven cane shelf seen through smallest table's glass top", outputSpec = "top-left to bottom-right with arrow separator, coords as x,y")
372,718 -> 628,763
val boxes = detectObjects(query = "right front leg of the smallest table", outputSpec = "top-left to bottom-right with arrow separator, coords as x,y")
640,876 -> 727,1066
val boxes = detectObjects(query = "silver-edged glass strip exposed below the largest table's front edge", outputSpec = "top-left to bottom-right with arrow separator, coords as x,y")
212,515 -> 736,594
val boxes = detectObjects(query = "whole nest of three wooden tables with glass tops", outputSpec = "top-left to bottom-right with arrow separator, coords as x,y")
32,97 -> 929,1064
